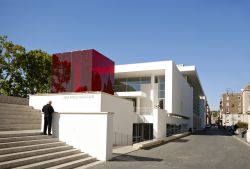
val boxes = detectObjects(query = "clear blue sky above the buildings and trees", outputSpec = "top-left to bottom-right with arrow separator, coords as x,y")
0,0 -> 250,110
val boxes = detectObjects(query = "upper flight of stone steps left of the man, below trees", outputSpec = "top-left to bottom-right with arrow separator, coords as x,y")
0,103 -> 42,131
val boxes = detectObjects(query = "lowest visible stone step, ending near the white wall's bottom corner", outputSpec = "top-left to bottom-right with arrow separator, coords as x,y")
47,157 -> 96,169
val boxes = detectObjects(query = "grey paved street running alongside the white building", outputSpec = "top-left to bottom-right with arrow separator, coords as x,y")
91,128 -> 250,169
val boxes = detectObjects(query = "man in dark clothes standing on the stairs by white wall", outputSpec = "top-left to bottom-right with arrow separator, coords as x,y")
42,101 -> 54,135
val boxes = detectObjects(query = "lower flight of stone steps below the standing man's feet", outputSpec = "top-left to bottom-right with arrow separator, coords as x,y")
0,130 -> 97,169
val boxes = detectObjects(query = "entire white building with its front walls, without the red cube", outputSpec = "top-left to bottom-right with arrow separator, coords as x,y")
29,61 -> 207,160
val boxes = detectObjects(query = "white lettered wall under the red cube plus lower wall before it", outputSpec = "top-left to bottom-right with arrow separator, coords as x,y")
29,92 -> 135,160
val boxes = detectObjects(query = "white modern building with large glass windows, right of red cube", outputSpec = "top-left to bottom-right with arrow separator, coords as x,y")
114,61 -> 206,141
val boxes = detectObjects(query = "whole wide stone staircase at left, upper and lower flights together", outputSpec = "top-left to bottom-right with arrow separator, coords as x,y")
0,103 -> 99,169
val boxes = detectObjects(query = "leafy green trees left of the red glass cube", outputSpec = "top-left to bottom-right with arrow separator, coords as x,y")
0,36 -> 51,97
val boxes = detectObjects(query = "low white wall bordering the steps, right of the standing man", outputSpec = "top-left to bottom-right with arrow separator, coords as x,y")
52,112 -> 113,161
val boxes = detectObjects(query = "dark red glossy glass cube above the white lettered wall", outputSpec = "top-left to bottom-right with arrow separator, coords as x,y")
52,49 -> 114,94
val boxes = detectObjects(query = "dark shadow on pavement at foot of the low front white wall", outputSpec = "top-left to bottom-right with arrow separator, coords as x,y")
110,155 -> 162,161
